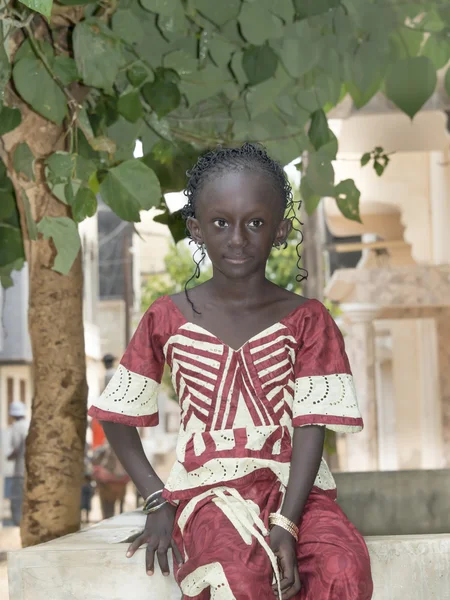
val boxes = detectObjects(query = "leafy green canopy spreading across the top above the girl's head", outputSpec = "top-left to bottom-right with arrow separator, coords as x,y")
0,0 -> 450,285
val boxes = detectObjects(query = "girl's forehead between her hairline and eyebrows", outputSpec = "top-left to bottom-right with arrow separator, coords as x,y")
196,170 -> 282,210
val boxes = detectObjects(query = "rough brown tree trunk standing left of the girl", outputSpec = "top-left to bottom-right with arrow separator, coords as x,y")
0,97 -> 87,546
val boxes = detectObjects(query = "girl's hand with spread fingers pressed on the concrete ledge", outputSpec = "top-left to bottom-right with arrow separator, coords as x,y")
127,504 -> 183,577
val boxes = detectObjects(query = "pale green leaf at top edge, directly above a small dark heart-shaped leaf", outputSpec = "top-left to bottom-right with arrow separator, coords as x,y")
238,2 -> 283,46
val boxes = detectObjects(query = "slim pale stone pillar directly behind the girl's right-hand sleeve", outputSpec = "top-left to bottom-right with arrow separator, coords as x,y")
340,304 -> 378,471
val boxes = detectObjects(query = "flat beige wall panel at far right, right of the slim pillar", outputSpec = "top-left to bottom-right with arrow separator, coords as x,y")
375,318 -> 444,470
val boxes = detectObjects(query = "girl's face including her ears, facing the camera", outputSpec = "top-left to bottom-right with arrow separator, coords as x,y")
187,170 -> 292,279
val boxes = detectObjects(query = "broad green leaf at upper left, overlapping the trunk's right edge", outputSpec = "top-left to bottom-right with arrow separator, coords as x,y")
73,19 -> 125,92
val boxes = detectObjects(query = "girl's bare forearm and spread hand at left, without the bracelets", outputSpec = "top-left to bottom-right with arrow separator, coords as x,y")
102,421 -> 183,576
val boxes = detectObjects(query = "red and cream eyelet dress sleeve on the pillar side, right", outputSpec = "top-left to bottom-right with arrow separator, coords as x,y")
292,302 -> 363,433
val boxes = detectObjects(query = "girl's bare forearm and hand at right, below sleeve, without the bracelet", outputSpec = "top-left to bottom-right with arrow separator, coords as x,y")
270,425 -> 325,600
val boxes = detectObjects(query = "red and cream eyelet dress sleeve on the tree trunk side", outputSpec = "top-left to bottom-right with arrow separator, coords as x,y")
88,305 -> 164,427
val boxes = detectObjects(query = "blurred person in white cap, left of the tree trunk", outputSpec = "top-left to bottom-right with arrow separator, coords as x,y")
7,401 -> 29,527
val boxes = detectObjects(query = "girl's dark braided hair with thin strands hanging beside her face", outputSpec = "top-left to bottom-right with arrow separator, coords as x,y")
181,142 -> 308,314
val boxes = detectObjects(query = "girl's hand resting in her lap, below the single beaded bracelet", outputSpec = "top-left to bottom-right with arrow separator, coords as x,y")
270,525 -> 302,600
